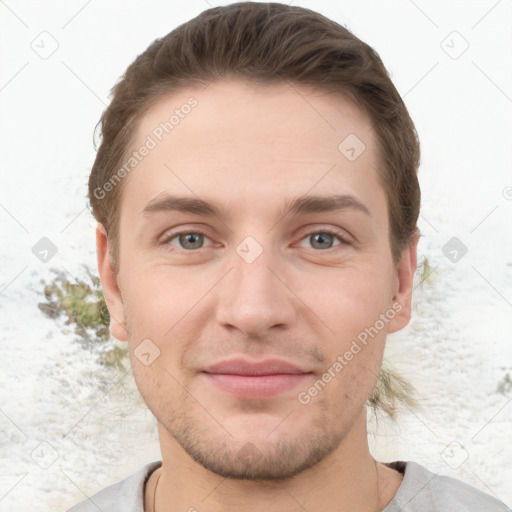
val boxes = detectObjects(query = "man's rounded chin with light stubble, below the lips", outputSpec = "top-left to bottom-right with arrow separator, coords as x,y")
166,402 -> 346,481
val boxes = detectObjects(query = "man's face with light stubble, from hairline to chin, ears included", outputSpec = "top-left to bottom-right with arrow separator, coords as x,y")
98,80 -> 415,479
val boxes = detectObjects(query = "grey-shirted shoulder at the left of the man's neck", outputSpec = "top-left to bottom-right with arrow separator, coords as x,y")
67,462 -> 162,512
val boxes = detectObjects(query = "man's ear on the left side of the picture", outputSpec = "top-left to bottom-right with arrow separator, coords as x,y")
96,223 -> 128,341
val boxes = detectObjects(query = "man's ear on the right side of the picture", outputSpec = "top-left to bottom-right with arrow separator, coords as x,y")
388,230 -> 420,333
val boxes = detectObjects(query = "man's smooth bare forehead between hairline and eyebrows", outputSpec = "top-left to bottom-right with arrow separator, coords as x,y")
123,80 -> 385,219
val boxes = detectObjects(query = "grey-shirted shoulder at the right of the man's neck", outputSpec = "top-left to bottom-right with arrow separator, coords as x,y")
383,462 -> 511,512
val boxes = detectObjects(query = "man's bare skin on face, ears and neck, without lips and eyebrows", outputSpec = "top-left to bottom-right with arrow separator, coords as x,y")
97,79 -> 417,512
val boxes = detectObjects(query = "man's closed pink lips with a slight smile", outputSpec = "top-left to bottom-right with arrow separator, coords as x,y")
202,358 -> 312,400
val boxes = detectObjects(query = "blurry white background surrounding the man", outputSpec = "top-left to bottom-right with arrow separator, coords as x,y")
0,0 -> 512,512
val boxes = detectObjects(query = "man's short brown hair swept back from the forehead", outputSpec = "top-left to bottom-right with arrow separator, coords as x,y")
89,2 -> 420,267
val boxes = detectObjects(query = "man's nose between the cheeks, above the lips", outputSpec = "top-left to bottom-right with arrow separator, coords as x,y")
217,242 -> 297,337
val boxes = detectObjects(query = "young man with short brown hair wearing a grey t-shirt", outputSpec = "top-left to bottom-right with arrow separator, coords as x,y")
71,3 -> 507,512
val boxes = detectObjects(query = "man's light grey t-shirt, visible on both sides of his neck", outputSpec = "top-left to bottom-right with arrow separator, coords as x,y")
67,461 -> 511,512
